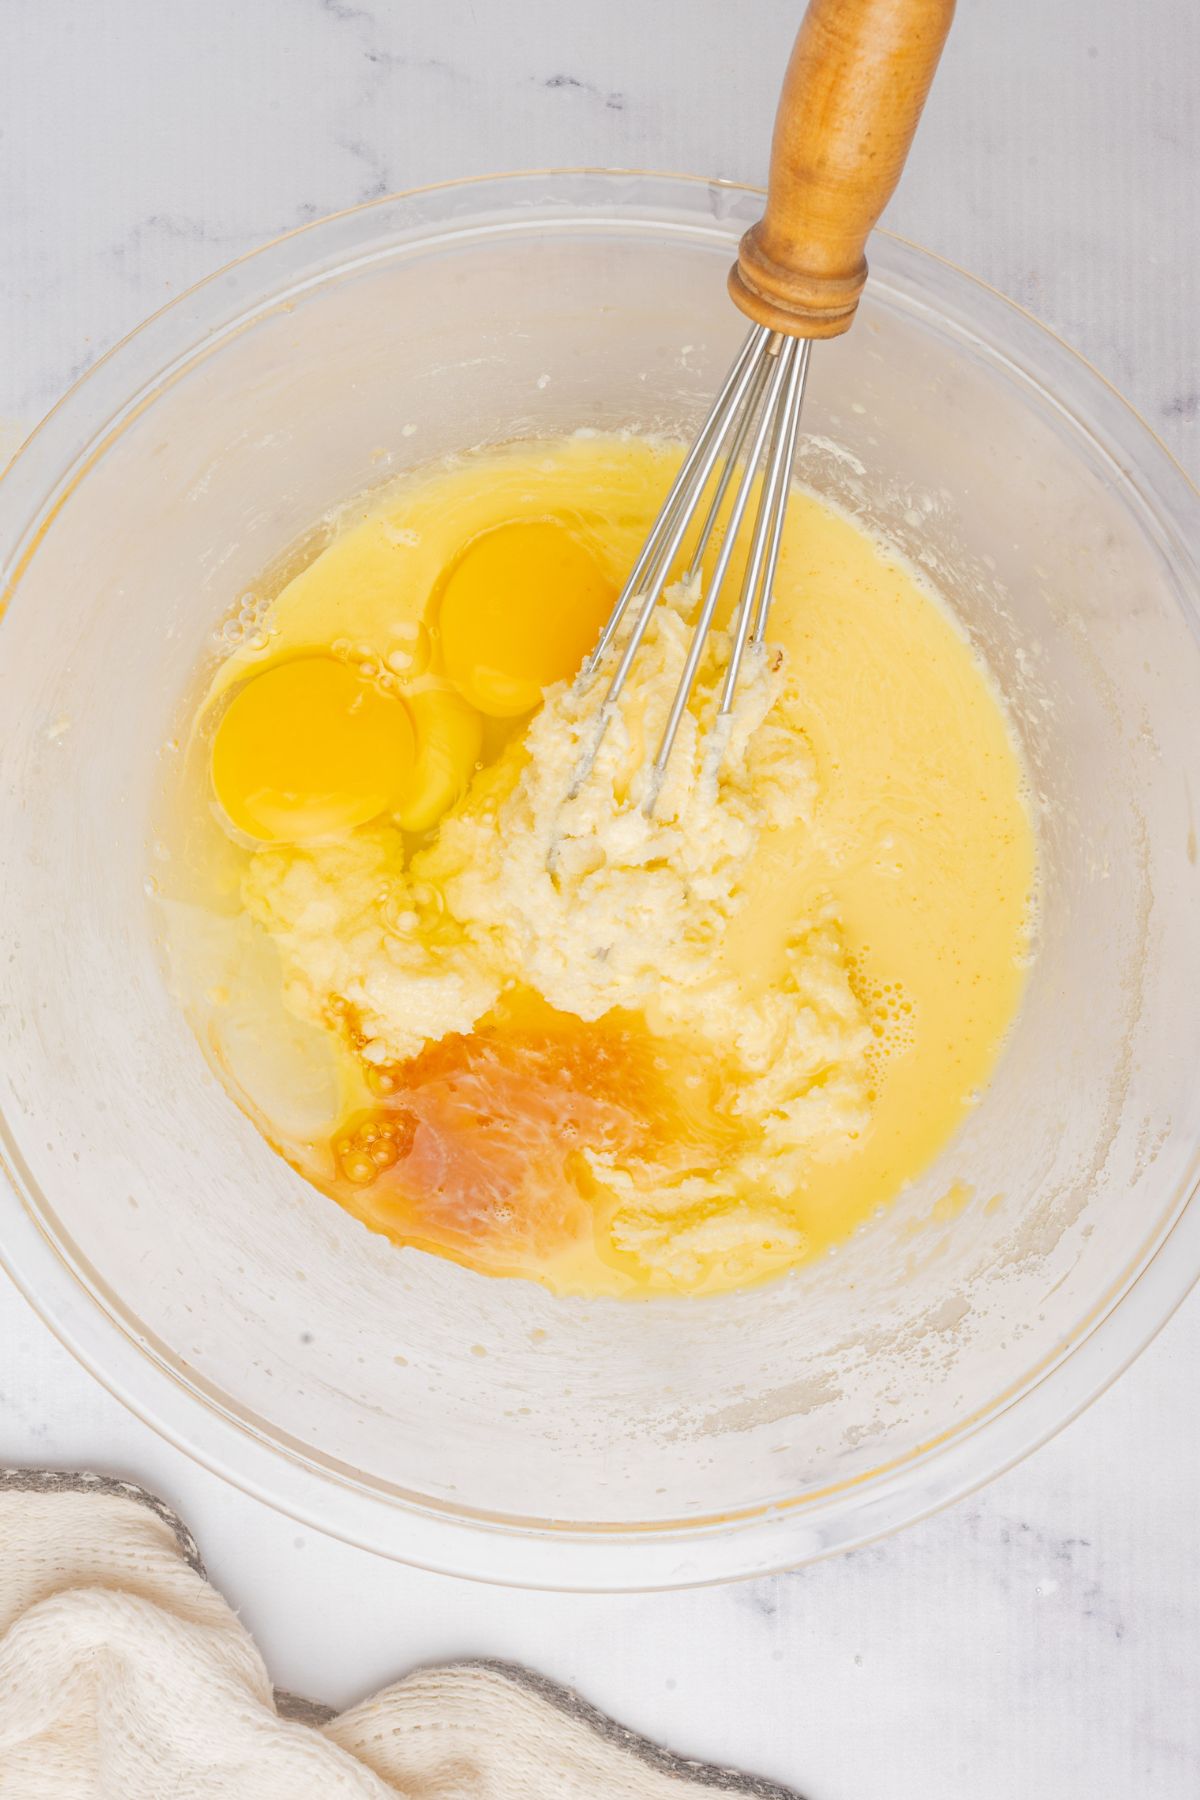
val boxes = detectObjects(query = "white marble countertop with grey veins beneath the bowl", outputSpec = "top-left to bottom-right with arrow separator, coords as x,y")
0,0 -> 1200,1800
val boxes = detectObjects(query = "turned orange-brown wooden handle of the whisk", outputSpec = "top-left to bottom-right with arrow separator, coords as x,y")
729,0 -> 954,338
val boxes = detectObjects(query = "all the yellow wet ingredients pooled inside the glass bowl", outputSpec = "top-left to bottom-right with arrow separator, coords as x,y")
164,434 -> 1034,1294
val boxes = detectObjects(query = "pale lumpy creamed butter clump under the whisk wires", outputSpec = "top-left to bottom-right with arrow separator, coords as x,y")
245,590 -> 871,1285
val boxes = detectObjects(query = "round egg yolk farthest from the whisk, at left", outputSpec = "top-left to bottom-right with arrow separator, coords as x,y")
212,655 -> 416,844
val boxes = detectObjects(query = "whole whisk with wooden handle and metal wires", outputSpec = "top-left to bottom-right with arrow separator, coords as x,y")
572,0 -> 954,795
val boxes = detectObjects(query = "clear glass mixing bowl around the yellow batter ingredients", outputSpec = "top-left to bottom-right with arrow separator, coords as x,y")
0,171 -> 1200,1588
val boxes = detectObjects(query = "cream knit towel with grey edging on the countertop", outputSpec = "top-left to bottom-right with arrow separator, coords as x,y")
0,1471 -> 795,1800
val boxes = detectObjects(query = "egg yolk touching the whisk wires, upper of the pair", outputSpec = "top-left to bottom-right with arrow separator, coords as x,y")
437,518 -> 617,718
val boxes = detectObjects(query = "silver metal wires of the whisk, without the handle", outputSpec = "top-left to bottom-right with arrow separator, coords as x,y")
572,326 -> 811,808
